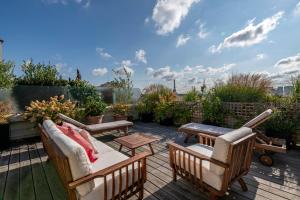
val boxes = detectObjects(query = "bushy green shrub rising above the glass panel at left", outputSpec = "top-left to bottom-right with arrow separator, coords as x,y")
17,60 -> 68,86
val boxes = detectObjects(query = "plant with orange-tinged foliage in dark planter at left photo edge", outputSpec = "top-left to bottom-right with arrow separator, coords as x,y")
0,102 -> 11,150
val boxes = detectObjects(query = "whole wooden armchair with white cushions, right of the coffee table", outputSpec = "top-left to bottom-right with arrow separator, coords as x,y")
169,127 -> 256,200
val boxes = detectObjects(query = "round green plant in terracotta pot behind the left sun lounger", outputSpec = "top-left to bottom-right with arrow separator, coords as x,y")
84,97 -> 106,124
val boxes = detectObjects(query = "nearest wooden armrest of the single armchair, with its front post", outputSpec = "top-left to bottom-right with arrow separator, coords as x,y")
168,142 -> 229,169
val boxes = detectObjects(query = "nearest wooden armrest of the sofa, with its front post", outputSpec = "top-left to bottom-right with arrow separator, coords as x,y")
69,151 -> 151,189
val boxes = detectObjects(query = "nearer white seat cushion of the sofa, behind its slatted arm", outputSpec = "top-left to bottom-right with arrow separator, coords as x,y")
79,149 -> 138,200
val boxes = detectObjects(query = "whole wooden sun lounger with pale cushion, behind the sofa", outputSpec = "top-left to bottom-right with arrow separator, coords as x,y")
58,113 -> 133,135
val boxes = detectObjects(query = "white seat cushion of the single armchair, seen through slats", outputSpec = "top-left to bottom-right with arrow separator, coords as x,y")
176,144 -> 223,190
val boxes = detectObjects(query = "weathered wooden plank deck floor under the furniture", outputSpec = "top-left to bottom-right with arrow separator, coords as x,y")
0,123 -> 300,200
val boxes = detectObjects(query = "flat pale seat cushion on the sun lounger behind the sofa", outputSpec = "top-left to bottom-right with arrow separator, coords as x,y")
86,120 -> 133,132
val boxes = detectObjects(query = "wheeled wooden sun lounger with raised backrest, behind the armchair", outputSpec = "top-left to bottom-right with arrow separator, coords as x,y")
178,109 -> 286,166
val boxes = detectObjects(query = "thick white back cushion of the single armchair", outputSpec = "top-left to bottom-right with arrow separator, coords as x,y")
211,127 -> 252,175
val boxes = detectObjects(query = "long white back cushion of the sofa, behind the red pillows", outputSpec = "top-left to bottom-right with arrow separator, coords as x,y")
43,120 -> 95,196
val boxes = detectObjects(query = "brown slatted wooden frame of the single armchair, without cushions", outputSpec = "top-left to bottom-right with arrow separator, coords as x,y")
169,133 -> 256,200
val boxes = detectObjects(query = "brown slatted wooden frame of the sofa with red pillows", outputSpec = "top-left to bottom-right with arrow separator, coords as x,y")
39,125 -> 151,200
